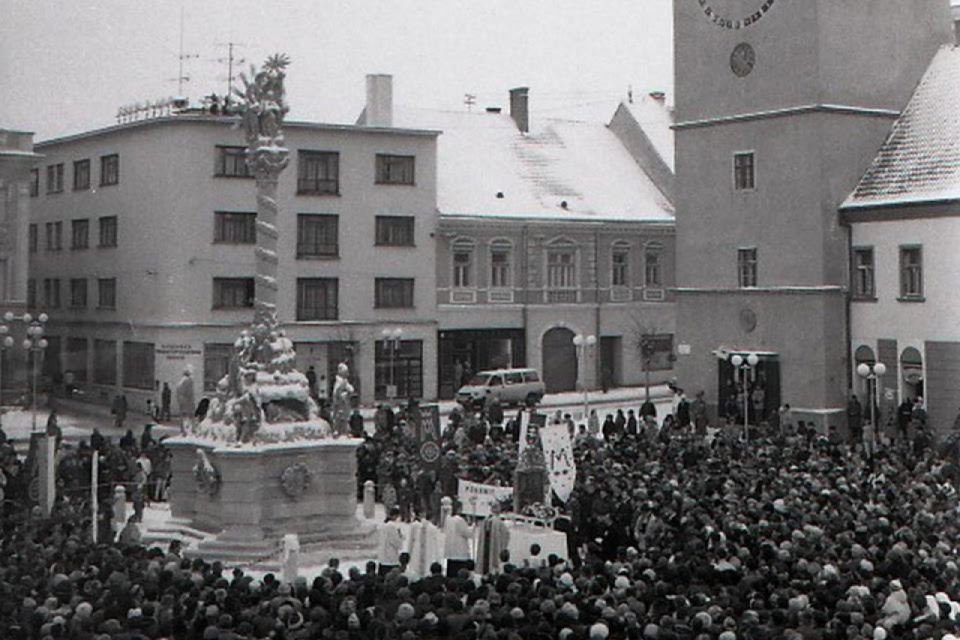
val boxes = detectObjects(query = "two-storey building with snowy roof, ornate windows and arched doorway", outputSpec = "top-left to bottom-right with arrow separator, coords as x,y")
395,88 -> 675,398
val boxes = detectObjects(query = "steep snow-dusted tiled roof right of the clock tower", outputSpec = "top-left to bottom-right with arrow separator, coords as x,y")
841,46 -> 960,209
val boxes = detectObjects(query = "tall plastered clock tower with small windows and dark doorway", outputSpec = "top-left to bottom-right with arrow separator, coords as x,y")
674,0 -> 953,428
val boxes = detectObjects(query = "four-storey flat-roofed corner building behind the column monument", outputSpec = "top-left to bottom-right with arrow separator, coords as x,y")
29,114 -> 437,408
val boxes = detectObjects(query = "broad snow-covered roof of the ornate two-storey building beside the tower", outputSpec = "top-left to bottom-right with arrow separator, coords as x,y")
394,108 -> 674,222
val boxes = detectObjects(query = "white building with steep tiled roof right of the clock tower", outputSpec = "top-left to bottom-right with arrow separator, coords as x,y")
841,47 -> 960,436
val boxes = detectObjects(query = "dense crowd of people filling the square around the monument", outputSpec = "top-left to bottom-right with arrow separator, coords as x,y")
0,388 -> 960,640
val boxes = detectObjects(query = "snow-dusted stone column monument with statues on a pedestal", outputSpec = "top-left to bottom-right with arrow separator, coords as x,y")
165,55 -> 375,562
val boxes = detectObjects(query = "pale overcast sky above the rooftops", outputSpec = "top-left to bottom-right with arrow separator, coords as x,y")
0,0 -> 673,140
